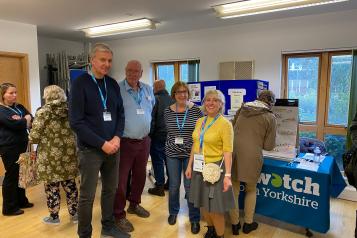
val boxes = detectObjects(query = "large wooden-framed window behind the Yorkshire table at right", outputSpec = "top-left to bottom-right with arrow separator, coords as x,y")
283,51 -> 352,169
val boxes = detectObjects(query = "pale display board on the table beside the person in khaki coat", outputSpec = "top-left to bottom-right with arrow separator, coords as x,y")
263,99 -> 299,161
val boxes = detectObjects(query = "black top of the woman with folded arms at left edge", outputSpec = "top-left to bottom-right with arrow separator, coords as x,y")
0,104 -> 31,147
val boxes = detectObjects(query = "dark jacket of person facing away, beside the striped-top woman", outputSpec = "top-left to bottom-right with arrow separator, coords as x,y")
149,90 -> 174,142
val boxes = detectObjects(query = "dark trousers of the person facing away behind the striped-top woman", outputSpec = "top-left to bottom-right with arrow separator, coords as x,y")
150,139 -> 168,186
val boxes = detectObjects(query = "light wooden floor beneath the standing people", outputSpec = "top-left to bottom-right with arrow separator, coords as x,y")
0,173 -> 357,238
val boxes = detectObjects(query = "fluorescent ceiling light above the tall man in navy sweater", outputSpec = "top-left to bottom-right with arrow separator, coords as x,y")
82,18 -> 155,37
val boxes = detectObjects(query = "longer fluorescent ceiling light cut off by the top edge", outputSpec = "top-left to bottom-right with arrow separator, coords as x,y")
213,0 -> 349,19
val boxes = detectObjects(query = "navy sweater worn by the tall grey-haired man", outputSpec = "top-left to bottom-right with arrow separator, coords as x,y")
69,74 -> 125,149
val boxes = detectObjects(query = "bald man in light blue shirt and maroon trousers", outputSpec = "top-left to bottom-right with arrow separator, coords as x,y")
114,60 -> 155,232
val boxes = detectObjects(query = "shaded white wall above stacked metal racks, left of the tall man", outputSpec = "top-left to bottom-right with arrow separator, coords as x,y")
38,36 -> 85,100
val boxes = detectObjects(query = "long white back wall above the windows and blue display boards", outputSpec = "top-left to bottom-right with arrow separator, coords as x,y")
107,10 -> 357,95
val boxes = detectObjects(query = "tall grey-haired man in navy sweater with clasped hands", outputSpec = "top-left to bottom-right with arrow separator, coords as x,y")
69,43 -> 130,238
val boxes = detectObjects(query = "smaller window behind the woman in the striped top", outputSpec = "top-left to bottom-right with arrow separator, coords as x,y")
153,60 -> 200,92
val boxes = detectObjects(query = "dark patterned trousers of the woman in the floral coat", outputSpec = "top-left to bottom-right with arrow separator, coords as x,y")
44,179 -> 78,219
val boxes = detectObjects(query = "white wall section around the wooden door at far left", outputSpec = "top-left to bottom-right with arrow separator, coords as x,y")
0,20 -> 41,112
